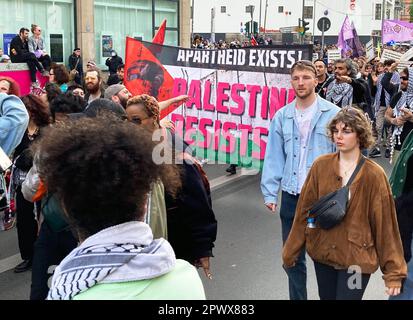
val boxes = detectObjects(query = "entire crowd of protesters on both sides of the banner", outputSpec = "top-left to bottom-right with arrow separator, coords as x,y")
0,25 -> 413,300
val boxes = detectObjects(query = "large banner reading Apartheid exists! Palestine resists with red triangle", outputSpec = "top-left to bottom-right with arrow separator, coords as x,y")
125,38 -> 312,169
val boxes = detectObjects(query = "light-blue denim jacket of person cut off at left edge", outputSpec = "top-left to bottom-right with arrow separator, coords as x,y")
0,93 -> 29,156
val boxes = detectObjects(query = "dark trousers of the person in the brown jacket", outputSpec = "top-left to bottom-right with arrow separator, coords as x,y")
314,261 -> 370,300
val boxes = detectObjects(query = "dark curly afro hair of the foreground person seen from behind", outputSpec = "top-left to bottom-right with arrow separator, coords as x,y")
34,116 -> 181,239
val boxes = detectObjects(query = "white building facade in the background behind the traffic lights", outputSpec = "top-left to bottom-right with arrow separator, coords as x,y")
192,0 -> 401,43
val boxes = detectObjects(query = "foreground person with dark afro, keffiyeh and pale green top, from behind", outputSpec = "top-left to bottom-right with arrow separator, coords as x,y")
36,115 -> 205,300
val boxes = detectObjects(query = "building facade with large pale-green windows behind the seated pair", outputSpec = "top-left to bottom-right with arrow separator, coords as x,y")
0,0 -> 190,68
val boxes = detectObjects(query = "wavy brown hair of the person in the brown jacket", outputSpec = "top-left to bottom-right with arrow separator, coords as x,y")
328,107 -> 374,150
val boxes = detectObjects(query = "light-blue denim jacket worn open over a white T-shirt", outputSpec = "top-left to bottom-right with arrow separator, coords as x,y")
261,97 -> 340,203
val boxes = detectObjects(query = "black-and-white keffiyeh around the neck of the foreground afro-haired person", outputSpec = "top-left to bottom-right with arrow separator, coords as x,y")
47,222 -> 176,300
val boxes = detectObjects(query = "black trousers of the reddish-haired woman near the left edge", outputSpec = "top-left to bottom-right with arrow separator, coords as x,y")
16,187 -> 37,260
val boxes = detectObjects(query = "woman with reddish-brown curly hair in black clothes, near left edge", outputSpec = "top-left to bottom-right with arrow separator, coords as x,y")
10,94 -> 50,273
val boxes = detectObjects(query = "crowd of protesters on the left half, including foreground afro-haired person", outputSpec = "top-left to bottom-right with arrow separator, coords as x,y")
0,38 -> 217,300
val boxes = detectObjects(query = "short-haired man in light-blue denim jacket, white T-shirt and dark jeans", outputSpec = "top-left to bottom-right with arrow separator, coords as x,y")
261,60 -> 340,300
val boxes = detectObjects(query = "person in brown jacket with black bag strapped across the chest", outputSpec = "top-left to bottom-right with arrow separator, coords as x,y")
283,107 -> 407,300
